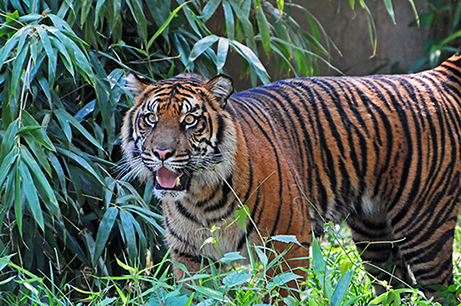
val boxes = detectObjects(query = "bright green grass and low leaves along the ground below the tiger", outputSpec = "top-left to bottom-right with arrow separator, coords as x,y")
0,224 -> 461,306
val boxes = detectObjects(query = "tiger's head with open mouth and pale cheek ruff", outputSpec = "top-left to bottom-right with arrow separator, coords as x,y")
121,73 -> 236,200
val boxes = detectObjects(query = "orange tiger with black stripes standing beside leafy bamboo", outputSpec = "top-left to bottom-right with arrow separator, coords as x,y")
121,50 -> 461,302
